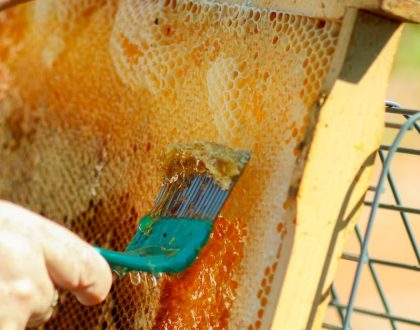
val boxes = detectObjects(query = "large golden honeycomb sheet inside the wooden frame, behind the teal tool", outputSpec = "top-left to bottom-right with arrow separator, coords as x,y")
0,0 -> 341,329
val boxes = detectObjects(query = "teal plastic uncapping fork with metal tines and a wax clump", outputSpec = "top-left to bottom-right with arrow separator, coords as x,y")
96,141 -> 251,273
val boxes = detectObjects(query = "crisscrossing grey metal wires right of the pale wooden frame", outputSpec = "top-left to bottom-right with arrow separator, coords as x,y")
323,101 -> 420,330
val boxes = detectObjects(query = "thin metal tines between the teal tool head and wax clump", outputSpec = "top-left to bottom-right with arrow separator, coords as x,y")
151,174 -> 230,220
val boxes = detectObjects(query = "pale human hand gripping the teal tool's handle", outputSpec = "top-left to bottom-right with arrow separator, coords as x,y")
0,201 -> 112,330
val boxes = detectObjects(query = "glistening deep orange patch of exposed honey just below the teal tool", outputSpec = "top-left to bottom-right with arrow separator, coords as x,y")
154,217 -> 245,329
